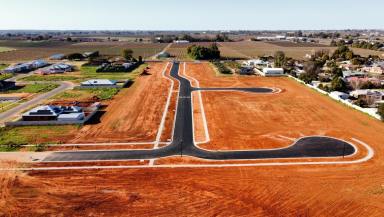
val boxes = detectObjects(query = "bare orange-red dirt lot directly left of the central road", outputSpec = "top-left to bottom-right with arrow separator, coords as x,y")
69,63 -> 170,143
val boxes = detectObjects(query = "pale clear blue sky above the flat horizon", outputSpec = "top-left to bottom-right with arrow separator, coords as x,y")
0,0 -> 384,30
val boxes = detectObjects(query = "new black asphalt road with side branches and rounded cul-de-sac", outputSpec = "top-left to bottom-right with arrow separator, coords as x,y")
43,63 -> 355,162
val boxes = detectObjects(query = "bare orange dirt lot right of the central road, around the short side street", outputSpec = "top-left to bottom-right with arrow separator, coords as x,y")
187,63 -> 384,150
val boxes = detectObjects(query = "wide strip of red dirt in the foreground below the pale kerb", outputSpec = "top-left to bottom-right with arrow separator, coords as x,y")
0,166 -> 384,216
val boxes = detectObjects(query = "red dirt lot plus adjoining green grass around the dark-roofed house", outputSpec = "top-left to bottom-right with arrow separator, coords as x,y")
0,63 -> 169,148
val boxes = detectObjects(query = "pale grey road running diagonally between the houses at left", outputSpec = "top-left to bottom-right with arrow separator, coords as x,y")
0,82 -> 73,124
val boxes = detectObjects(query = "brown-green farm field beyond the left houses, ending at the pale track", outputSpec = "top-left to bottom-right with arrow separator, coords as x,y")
0,41 -> 167,62
